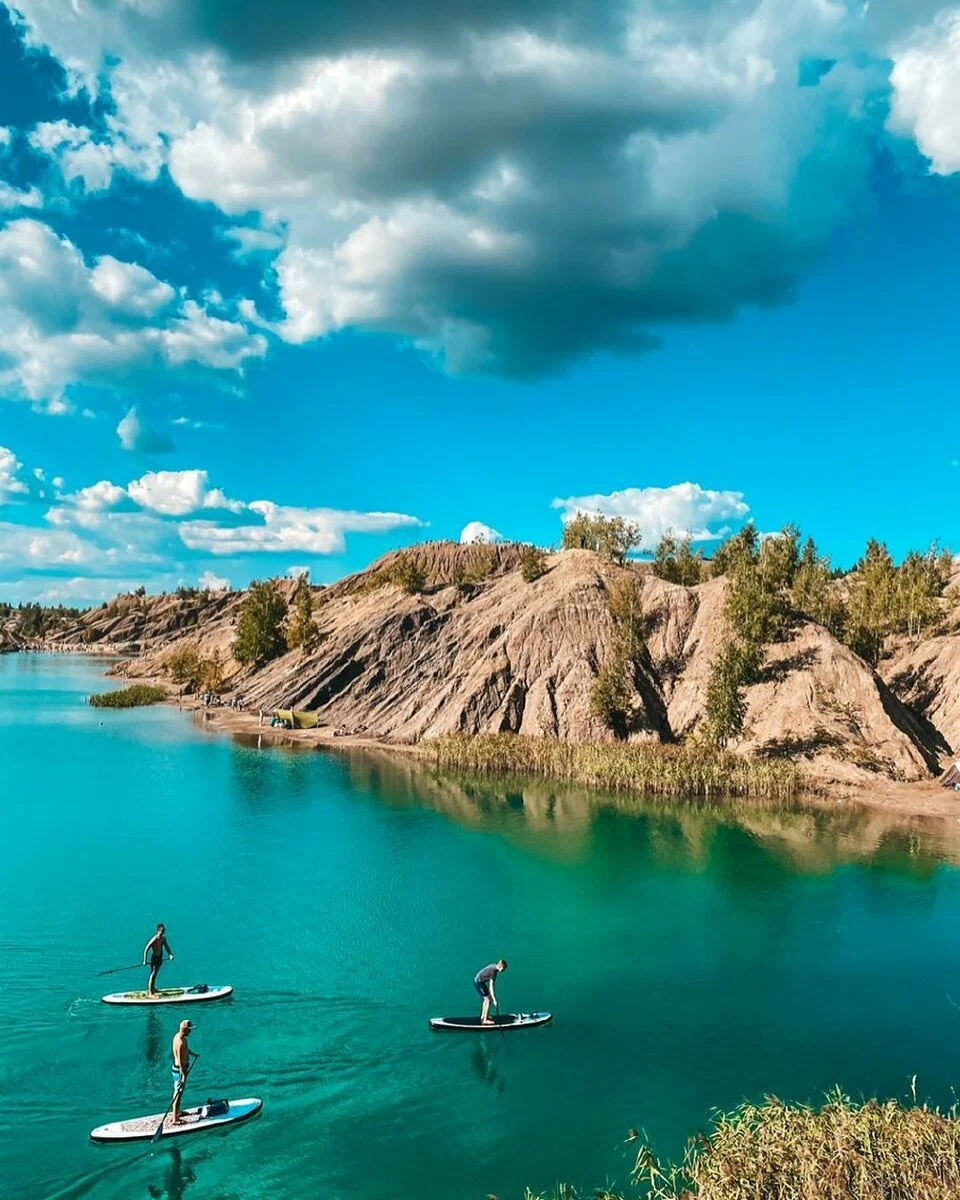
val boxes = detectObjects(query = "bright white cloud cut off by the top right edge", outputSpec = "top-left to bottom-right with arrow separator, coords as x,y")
890,8 -> 960,175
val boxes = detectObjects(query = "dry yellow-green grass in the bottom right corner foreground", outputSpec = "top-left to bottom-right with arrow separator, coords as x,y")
527,1091 -> 960,1200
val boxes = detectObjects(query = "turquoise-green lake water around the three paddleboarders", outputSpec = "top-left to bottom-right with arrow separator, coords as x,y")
0,655 -> 960,1200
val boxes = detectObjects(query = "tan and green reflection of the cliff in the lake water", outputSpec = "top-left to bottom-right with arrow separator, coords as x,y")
343,750 -> 960,878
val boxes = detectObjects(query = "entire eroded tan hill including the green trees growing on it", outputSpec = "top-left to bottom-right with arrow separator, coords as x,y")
7,515 -> 960,780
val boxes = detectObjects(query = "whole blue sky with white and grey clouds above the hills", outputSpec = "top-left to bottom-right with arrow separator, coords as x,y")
0,0 -> 960,602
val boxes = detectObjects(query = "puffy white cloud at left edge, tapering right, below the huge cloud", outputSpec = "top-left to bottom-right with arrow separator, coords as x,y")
0,217 -> 266,410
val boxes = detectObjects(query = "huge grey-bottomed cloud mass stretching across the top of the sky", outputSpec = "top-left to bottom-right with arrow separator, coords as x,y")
5,0 -> 956,377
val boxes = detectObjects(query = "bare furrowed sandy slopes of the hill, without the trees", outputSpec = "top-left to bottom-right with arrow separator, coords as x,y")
31,542 -> 945,780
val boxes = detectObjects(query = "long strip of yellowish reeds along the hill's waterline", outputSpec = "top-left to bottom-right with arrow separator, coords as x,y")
422,733 -> 802,799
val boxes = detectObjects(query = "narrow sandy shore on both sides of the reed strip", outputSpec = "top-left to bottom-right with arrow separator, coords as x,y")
157,680 -> 960,824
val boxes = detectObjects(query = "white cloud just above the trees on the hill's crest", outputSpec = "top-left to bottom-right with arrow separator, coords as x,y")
553,484 -> 750,550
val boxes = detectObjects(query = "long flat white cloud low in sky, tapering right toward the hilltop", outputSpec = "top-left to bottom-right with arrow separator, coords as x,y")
180,500 -> 422,554
